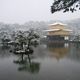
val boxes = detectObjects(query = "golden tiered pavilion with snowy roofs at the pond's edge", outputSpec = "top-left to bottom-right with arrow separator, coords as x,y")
45,23 -> 72,41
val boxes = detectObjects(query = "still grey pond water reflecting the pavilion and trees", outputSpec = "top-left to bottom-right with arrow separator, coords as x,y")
0,43 -> 80,80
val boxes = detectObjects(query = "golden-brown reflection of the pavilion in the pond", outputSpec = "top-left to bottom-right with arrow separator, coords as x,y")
47,43 -> 69,59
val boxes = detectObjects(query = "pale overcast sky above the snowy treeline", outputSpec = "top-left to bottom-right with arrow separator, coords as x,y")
0,0 -> 80,23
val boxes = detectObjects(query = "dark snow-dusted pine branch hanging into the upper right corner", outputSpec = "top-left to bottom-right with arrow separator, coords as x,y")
51,0 -> 80,13
